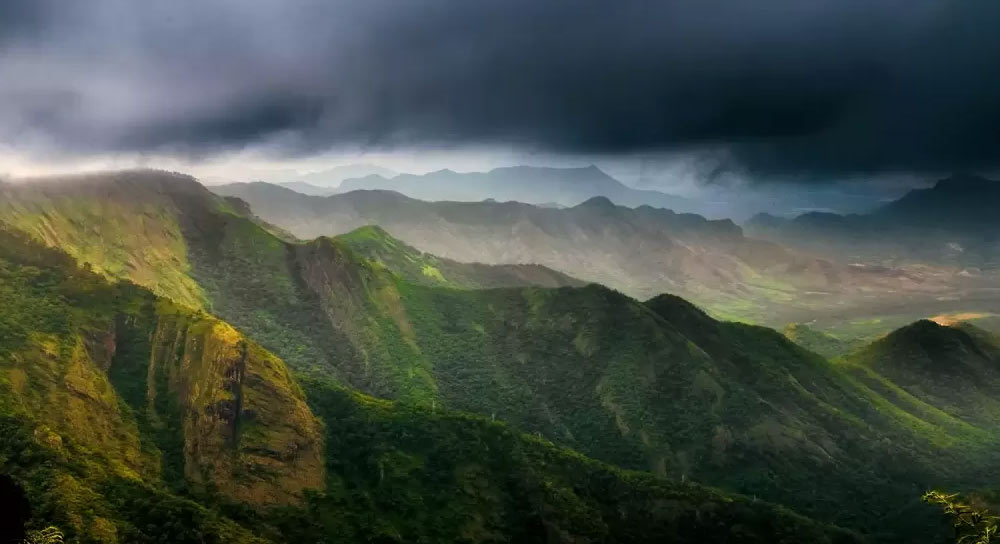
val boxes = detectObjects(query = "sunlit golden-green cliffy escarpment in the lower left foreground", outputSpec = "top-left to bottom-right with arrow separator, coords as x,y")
0,225 -> 324,541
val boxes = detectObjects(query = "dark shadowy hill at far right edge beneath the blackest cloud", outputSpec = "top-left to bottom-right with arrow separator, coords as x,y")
746,175 -> 1000,268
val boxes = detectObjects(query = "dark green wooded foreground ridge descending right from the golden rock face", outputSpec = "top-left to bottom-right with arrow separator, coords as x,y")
268,382 -> 857,543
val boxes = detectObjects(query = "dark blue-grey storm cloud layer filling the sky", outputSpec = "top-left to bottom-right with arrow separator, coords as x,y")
0,0 -> 1000,174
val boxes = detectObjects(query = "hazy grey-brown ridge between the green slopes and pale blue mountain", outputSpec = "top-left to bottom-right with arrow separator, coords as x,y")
212,183 -> 976,325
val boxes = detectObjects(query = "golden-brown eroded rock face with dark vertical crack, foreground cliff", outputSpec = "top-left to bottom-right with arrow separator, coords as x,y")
148,316 -> 324,506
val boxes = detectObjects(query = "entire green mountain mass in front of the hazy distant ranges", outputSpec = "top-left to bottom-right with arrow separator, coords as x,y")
0,171 -> 998,542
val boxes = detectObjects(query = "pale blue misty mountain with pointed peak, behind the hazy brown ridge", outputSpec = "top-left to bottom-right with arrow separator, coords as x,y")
340,166 -> 698,211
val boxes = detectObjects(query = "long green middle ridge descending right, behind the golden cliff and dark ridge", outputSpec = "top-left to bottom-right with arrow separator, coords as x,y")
3,171 -> 996,536
